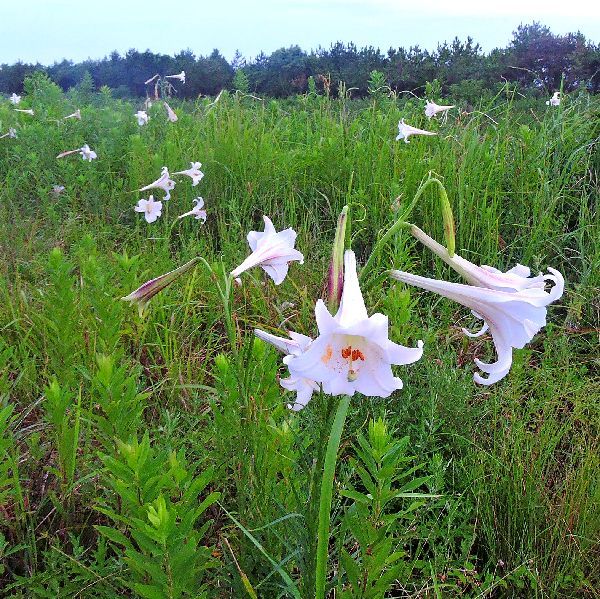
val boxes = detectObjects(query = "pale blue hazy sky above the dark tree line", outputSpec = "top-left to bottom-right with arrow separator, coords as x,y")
0,0 -> 600,64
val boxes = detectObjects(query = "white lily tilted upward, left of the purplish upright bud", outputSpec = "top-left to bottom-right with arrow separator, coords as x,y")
231,216 -> 304,285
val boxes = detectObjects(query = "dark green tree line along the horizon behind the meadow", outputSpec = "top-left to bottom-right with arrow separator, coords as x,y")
0,22 -> 600,98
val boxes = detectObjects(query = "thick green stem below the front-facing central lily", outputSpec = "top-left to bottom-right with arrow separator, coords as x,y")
315,395 -> 350,599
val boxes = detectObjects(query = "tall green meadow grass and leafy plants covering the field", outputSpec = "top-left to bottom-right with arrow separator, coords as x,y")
0,79 -> 600,598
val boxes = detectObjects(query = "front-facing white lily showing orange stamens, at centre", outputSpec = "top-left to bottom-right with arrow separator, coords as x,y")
284,250 -> 423,397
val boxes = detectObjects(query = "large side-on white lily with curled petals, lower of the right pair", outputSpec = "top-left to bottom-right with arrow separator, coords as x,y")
390,268 -> 565,385
